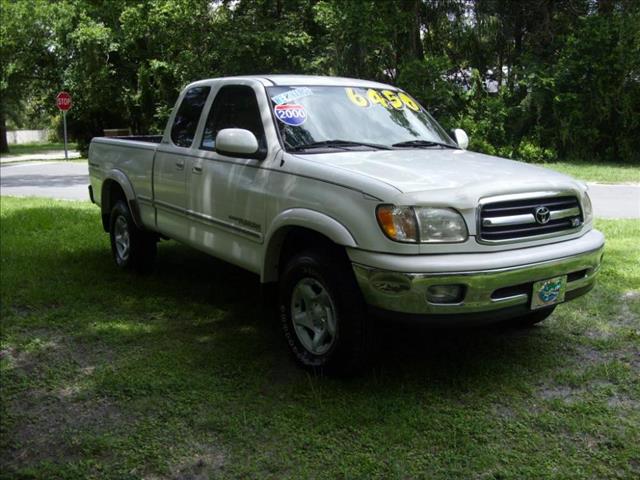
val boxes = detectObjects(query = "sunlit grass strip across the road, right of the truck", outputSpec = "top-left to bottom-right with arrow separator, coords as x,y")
539,162 -> 640,183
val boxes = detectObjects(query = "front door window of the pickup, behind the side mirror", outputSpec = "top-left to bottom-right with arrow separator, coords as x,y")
200,85 -> 267,158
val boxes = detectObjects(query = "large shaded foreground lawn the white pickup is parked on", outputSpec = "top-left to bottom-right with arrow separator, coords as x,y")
0,197 -> 640,479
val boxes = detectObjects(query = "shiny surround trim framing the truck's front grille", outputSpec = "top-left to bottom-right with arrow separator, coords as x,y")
475,189 -> 587,245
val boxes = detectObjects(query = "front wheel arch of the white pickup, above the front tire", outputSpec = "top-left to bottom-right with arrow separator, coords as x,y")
260,208 -> 358,283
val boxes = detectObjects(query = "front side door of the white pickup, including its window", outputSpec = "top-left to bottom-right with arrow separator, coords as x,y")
189,85 -> 269,271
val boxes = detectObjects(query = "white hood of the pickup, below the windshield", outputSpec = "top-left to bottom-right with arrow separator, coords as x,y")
300,148 -> 584,205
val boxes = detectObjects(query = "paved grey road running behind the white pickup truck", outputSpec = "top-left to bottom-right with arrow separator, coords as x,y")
0,162 -> 640,218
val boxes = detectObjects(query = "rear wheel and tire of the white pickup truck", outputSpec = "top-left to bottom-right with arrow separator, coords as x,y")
109,200 -> 158,273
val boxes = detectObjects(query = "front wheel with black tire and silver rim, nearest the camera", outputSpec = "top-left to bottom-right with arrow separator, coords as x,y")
278,250 -> 373,375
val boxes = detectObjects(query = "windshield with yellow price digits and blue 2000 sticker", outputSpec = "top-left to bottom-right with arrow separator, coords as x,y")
267,86 -> 457,153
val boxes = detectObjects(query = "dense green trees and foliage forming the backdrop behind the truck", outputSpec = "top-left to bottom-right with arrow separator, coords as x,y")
0,0 -> 640,163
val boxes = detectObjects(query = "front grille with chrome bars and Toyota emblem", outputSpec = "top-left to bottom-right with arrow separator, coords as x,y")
479,196 -> 583,242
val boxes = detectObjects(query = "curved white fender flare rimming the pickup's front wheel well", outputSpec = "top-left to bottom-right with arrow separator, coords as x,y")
260,208 -> 358,283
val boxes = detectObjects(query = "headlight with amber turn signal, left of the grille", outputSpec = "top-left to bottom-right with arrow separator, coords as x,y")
376,205 -> 468,243
